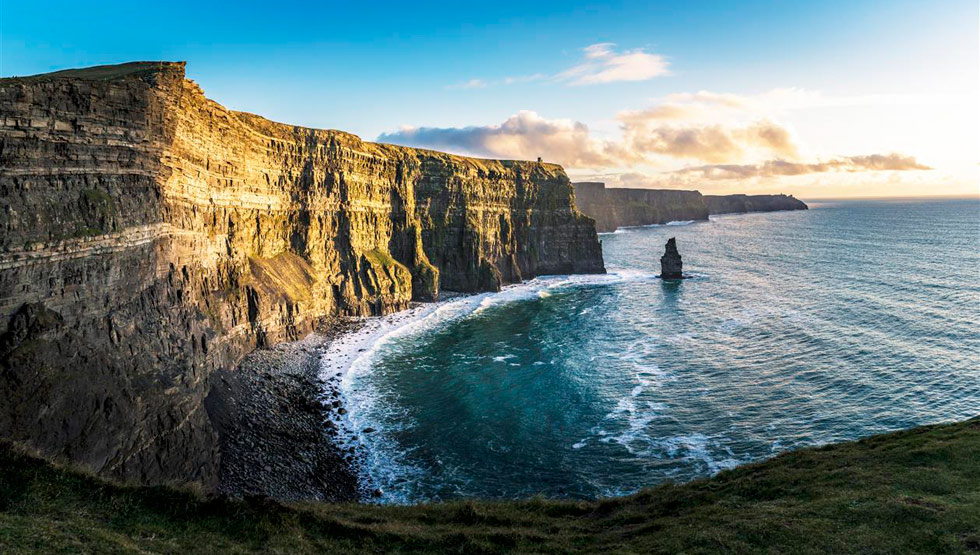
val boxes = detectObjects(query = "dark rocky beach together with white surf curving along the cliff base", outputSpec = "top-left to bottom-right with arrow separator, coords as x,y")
206,270 -> 657,503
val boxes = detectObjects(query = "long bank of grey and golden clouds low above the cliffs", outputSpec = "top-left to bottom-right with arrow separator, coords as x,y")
378,110 -> 931,174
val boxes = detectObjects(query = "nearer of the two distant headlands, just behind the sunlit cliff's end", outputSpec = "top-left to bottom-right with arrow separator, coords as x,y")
575,182 -> 708,233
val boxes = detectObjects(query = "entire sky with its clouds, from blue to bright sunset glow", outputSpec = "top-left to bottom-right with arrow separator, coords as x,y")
0,0 -> 980,199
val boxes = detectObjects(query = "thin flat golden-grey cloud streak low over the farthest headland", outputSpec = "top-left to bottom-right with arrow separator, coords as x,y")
673,153 -> 933,179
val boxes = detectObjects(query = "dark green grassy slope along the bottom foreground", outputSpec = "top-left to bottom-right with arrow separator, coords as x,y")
0,418 -> 980,553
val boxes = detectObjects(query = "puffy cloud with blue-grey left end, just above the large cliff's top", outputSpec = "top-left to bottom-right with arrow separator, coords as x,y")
378,110 -> 630,167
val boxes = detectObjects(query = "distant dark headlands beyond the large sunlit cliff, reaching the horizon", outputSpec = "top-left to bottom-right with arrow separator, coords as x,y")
573,182 -> 807,233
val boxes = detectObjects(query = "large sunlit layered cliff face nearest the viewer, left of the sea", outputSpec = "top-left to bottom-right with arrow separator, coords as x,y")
0,63 -> 604,485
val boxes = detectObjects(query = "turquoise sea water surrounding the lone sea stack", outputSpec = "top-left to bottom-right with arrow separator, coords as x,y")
344,200 -> 980,503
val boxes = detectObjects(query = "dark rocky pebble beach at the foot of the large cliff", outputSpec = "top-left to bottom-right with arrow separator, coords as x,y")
205,319 -> 365,502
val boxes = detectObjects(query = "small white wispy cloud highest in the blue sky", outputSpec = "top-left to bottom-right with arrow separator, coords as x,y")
555,42 -> 670,86
